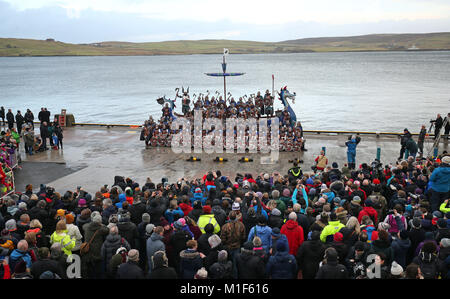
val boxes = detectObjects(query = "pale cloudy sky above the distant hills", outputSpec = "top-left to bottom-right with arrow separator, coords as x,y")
0,0 -> 450,43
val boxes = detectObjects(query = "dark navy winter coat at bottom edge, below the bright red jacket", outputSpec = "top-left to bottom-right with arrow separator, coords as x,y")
266,251 -> 297,279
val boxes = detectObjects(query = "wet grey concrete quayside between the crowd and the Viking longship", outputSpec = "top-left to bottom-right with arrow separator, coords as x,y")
16,127 -> 449,193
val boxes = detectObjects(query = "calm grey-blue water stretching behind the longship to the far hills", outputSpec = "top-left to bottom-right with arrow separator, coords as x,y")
0,52 -> 450,132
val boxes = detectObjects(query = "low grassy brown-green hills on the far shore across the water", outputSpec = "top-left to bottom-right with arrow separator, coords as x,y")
0,32 -> 450,56
